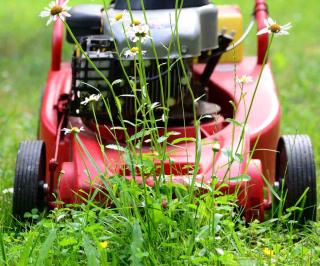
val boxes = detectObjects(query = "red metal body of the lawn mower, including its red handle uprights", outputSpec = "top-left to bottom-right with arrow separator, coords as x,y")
40,0 -> 280,220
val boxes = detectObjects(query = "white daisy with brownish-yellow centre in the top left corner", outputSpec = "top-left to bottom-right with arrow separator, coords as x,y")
39,0 -> 71,26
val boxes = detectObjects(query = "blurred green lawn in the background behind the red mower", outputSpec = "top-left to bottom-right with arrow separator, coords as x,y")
0,0 -> 320,212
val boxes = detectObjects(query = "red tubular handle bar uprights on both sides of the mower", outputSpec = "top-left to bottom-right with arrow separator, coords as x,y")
51,0 -> 269,71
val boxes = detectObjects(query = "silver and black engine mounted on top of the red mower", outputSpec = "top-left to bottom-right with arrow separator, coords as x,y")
67,0 -> 231,124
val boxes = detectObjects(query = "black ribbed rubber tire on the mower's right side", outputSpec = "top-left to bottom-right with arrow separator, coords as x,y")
276,135 -> 317,224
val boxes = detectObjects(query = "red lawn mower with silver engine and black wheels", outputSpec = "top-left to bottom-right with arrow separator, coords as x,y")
13,0 -> 317,221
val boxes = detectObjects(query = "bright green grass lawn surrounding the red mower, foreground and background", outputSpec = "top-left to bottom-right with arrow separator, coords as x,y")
0,0 -> 320,265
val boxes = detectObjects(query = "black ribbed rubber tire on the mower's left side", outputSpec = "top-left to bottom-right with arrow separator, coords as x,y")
12,140 -> 46,220
